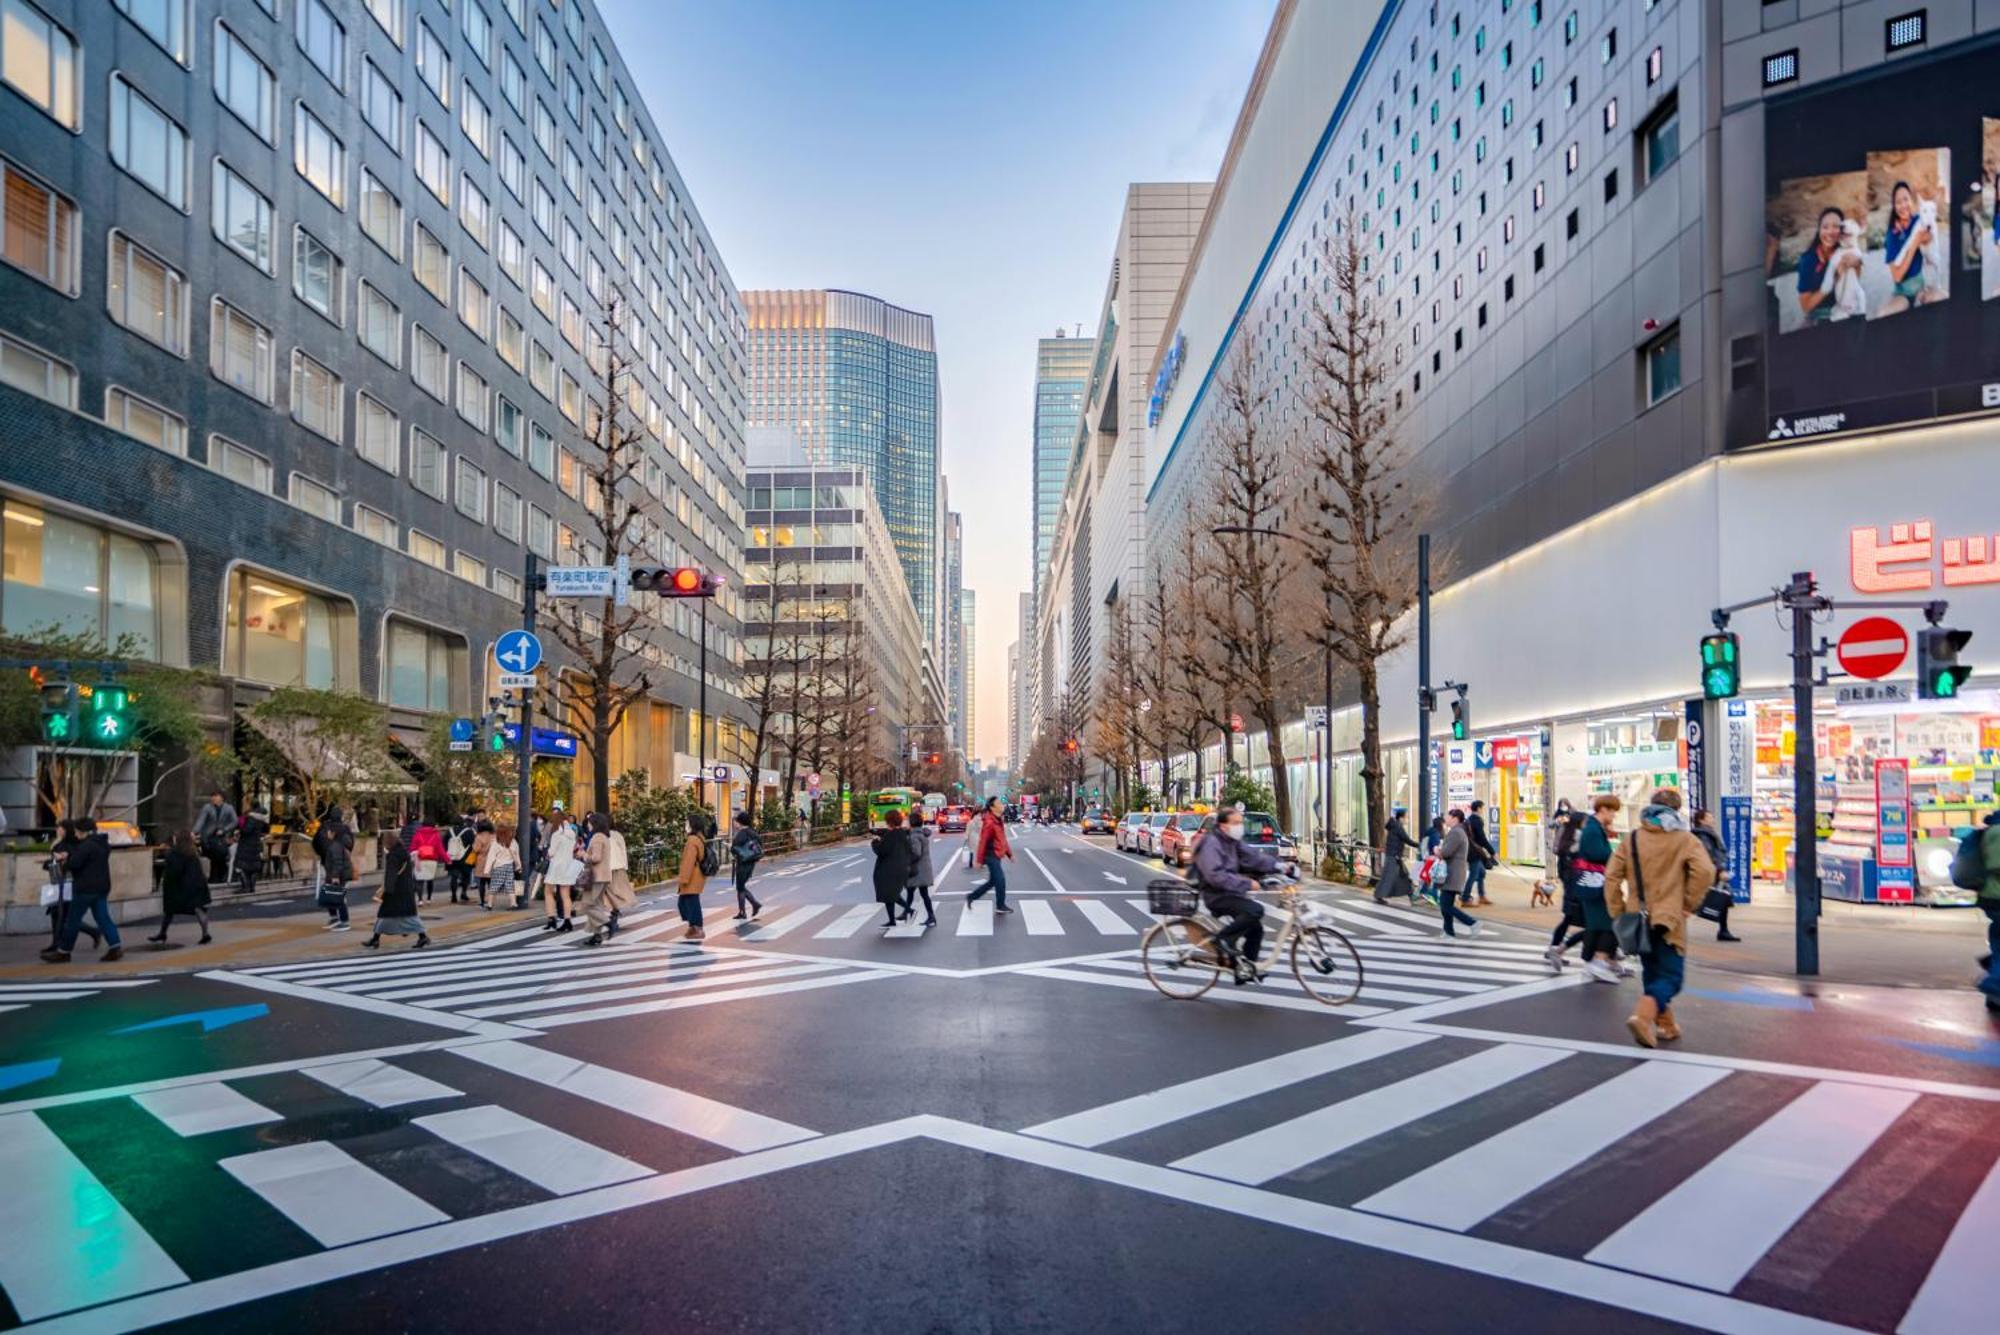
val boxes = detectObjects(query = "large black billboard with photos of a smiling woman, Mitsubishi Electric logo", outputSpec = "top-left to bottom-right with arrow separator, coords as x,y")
1732,42 -> 2000,446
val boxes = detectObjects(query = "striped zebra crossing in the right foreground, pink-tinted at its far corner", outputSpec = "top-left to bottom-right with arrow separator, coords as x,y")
1026,1029 -> 2000,1335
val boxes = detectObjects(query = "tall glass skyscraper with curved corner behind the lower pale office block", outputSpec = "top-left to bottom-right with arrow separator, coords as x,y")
742,290 -> 944,648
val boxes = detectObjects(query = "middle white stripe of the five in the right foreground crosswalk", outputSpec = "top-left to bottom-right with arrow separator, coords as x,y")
1354,1061 -> 1728,1231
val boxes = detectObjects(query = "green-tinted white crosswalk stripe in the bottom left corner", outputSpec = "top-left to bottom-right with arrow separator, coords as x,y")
0,1113 -> 188,1321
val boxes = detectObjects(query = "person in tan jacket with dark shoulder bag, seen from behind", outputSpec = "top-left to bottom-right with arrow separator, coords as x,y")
1604,787 -> 1716,1047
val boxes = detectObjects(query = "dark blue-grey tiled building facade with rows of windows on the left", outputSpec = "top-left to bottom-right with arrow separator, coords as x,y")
0,0 -> 742,835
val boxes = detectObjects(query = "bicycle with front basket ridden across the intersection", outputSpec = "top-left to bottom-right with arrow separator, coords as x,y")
1140,877 -> 1362,1005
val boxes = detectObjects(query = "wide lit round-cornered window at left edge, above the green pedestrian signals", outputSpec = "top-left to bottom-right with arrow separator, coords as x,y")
0,500 -> 160,658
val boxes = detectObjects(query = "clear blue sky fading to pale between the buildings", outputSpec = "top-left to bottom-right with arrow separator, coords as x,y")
598,0 -> 1272,763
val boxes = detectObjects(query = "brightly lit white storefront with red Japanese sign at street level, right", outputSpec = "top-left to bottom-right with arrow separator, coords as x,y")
1304,420 -> 2000,903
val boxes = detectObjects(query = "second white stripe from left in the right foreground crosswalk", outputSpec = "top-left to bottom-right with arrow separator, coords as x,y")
1174,1045 -> 1576,1183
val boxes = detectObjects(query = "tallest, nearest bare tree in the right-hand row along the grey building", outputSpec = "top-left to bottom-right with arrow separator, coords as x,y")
1304,210 -> 1426,847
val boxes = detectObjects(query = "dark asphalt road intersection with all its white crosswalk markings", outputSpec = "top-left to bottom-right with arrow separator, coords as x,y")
0,829 -> 2000,1335
